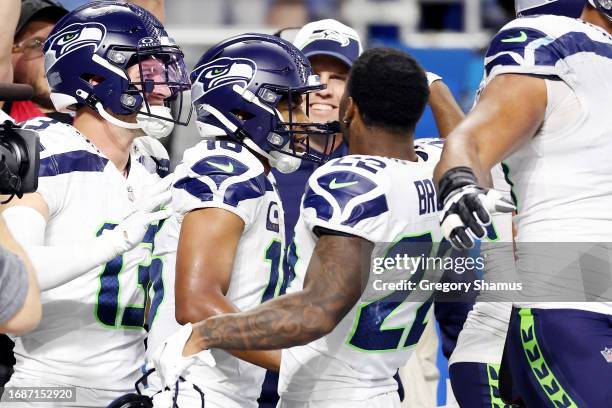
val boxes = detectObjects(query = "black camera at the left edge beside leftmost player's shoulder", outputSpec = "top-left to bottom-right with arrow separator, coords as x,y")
0,120 -> 40,200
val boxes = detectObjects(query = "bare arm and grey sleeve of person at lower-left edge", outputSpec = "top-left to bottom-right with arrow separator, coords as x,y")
0,218 -> 41,334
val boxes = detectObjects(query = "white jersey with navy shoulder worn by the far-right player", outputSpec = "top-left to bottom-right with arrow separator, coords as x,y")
483,16 -> 612,313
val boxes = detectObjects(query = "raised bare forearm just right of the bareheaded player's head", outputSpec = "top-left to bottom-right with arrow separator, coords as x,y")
428,81 -> 465,138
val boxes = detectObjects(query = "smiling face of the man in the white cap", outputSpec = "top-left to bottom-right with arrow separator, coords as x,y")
308,55 -> 349,123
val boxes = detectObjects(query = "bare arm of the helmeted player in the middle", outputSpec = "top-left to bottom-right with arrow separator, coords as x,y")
176,208 -> 280,371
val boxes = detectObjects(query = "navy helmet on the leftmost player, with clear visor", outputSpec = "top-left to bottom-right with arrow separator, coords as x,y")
44,1 -> 191,137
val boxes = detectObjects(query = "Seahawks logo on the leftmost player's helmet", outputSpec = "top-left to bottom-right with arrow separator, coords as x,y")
45,23 -> 106,69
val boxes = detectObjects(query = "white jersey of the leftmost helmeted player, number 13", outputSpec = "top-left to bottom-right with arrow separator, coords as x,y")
10,118 -> 169,392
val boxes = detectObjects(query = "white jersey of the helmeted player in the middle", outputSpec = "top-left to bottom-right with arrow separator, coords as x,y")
148,140 -> 284,407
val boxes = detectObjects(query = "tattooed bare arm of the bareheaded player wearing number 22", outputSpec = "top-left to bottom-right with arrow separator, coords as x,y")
191,235 -> 371,350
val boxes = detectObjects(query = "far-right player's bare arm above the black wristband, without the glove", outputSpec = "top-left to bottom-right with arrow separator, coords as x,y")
434,74 -> 547,183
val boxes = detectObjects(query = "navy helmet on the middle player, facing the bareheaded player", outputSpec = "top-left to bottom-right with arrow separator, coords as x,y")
190,34 -> 339,173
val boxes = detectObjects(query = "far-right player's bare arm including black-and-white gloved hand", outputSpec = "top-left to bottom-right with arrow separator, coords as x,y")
434,74 -> 547,248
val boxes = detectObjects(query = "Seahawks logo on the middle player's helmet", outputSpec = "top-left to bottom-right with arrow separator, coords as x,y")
193,57 -> 257,100
